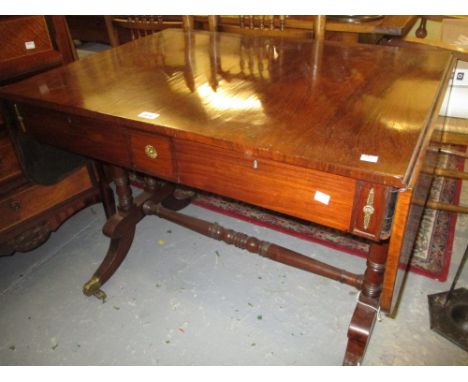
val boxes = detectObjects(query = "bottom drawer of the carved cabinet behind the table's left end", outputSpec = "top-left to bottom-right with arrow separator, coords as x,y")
0,167 -> 92,231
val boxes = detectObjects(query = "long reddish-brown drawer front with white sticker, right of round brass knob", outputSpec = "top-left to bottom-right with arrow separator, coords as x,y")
176,140 -> 355,231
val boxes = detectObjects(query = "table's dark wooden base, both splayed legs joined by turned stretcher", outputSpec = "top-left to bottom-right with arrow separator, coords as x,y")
83,167 -> 388,365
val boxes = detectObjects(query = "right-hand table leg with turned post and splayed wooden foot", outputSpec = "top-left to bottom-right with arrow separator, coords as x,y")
343,242 -> 388,366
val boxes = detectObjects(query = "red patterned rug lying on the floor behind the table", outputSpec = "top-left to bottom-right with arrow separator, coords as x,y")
187,148 -> 464,281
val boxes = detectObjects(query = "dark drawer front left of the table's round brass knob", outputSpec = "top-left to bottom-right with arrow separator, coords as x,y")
18,105 -> 130,167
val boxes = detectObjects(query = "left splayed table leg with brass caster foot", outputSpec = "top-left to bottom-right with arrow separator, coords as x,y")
83,167 -> 175,300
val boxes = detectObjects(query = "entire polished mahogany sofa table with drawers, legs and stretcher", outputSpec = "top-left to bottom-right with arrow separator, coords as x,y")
0,29 -> 454,364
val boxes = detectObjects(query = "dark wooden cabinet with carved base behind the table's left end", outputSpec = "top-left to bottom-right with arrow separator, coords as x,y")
0,16 -> 112,255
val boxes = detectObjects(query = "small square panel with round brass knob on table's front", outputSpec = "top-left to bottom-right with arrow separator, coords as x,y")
130,134 -> 176,180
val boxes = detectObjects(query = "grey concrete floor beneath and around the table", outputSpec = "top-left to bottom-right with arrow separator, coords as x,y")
0,187 -> 468,365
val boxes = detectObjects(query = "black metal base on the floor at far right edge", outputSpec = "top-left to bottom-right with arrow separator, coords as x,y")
427,246 -> 468,351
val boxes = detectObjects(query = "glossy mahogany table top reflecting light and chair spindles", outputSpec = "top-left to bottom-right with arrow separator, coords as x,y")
0,30 -> 451,187
